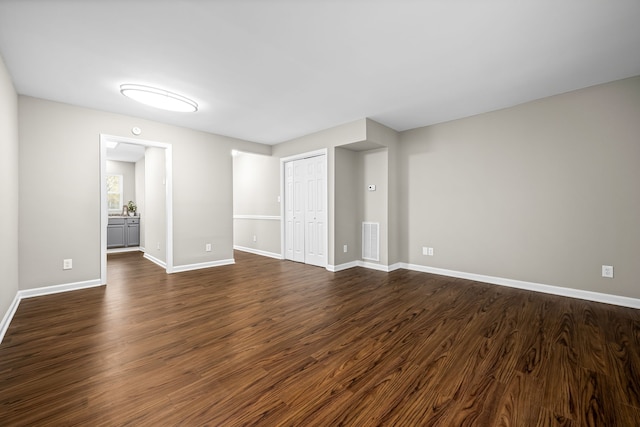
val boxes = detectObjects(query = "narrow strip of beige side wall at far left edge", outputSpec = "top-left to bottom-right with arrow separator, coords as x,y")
0,57 -> 18,326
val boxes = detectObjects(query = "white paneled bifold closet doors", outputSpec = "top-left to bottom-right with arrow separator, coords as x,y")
284,155 -> 327,267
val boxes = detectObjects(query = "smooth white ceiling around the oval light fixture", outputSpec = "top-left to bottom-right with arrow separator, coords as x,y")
0,0 -> 640,144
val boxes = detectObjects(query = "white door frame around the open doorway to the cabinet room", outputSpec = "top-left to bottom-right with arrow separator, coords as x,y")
100,134 -> 173,285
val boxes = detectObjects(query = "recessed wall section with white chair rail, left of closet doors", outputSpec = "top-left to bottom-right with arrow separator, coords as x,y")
233,153 -> 281,255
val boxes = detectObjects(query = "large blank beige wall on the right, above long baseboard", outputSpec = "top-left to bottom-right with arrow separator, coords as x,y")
399,77 -> 640,298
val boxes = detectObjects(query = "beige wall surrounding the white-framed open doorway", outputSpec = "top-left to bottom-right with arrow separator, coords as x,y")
18,96 -> 271,289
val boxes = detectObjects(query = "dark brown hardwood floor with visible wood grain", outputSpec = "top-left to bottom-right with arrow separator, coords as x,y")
0,252 -> 640,427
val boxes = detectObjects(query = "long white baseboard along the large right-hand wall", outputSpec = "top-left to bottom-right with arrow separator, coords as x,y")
401,263 -> 640,309
